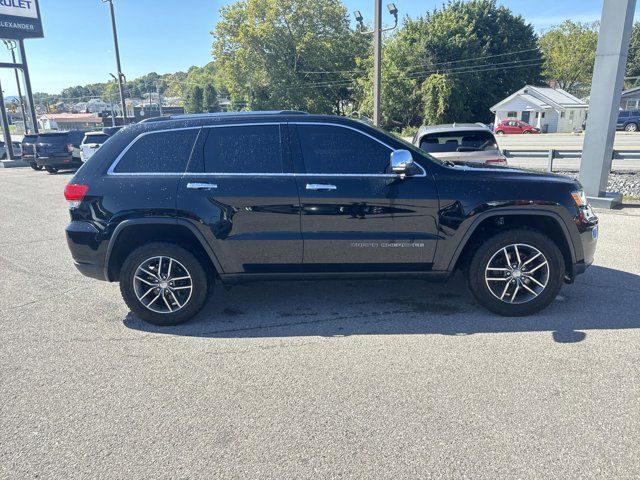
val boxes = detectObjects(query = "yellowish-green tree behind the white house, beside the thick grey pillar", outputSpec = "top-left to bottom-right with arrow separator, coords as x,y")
540,20 -> 598,95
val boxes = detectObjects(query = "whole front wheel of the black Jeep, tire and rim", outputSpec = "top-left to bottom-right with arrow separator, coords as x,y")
468,229 -> 565,317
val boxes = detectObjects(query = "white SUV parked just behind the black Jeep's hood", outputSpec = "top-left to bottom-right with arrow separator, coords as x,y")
413,123 -> 507,166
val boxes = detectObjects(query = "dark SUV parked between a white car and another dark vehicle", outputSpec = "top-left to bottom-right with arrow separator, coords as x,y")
36,130 -> 84,173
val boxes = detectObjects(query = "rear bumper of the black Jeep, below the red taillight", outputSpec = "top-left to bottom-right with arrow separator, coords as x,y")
65,222 -> 107,281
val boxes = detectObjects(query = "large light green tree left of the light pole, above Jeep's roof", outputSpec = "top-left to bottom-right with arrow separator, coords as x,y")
213,0 -> 369,113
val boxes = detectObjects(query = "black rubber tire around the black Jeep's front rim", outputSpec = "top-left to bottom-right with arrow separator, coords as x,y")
468,229 -> 565,317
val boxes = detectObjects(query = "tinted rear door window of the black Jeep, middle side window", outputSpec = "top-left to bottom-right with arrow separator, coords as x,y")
204,125 -> 282,173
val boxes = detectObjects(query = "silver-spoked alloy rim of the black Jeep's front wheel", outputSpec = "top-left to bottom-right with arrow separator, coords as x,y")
484,243 -> 550,305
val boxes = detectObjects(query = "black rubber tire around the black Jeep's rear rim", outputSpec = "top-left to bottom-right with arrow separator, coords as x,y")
120,243 -> 209,326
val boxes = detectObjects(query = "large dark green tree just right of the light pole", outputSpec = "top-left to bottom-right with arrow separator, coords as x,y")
359,0 -> 542,129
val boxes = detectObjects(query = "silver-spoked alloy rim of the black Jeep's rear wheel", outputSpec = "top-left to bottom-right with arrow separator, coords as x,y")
133,256 -> 193,314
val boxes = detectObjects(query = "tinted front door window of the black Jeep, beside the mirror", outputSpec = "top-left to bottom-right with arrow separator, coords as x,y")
298,125 -> 391,175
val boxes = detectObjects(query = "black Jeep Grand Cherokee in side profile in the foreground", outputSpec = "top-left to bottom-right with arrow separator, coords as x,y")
65,112 -> 598,325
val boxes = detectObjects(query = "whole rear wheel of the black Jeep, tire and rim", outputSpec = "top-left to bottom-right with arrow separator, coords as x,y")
120,243 -> 209,326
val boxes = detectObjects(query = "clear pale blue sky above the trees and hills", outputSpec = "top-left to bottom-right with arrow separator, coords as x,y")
0,0 -> 620,95
